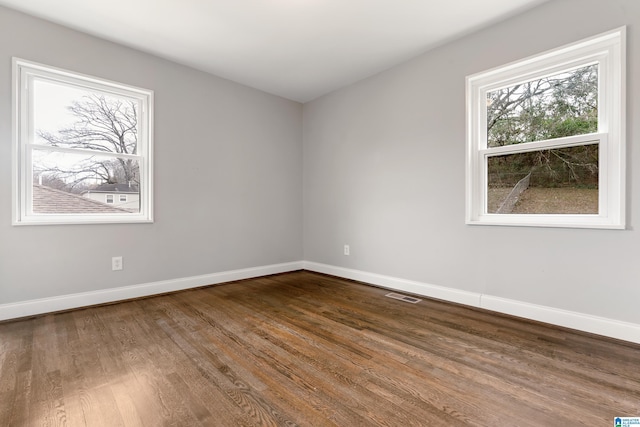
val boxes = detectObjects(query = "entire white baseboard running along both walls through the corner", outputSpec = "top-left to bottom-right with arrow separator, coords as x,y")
0,261 -> 640,344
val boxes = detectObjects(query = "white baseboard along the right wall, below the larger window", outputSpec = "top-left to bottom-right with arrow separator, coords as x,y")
303,261 -> 640,344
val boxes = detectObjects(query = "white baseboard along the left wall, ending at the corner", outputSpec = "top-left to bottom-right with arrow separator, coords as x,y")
0,261 -> 303,320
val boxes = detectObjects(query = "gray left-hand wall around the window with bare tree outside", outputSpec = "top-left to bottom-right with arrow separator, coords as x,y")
0,7 -> 302,304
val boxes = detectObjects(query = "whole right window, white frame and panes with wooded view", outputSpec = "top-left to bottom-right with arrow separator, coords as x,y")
466,28 -> 625,228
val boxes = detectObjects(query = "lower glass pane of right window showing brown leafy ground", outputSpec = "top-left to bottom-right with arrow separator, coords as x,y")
487,144 -> 598,214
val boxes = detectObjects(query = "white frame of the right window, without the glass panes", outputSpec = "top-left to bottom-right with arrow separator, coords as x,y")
466,27 -> 626,229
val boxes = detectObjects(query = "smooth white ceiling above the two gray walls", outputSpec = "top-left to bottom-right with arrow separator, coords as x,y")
0,0 -> 546,102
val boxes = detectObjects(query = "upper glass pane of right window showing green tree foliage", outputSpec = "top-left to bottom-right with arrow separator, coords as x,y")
486,64 -> 598,148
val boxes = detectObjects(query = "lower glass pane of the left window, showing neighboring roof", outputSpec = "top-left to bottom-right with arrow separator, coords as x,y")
32,150 -> 140,214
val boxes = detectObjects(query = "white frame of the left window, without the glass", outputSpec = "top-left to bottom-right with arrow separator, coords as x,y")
12,58 -> 153,225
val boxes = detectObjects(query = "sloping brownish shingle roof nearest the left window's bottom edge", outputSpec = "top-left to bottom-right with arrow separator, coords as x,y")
33,184 -> 130,214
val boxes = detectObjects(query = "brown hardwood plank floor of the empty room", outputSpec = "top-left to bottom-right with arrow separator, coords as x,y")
0,271 -> 640,427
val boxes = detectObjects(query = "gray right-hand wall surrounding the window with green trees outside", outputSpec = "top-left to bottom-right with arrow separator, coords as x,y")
303,0 -> 640,323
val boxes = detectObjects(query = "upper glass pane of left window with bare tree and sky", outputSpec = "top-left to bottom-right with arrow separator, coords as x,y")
33,80 -> 138,154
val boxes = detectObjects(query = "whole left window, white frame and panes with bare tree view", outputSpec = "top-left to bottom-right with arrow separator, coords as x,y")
13,58 -> 153,225
